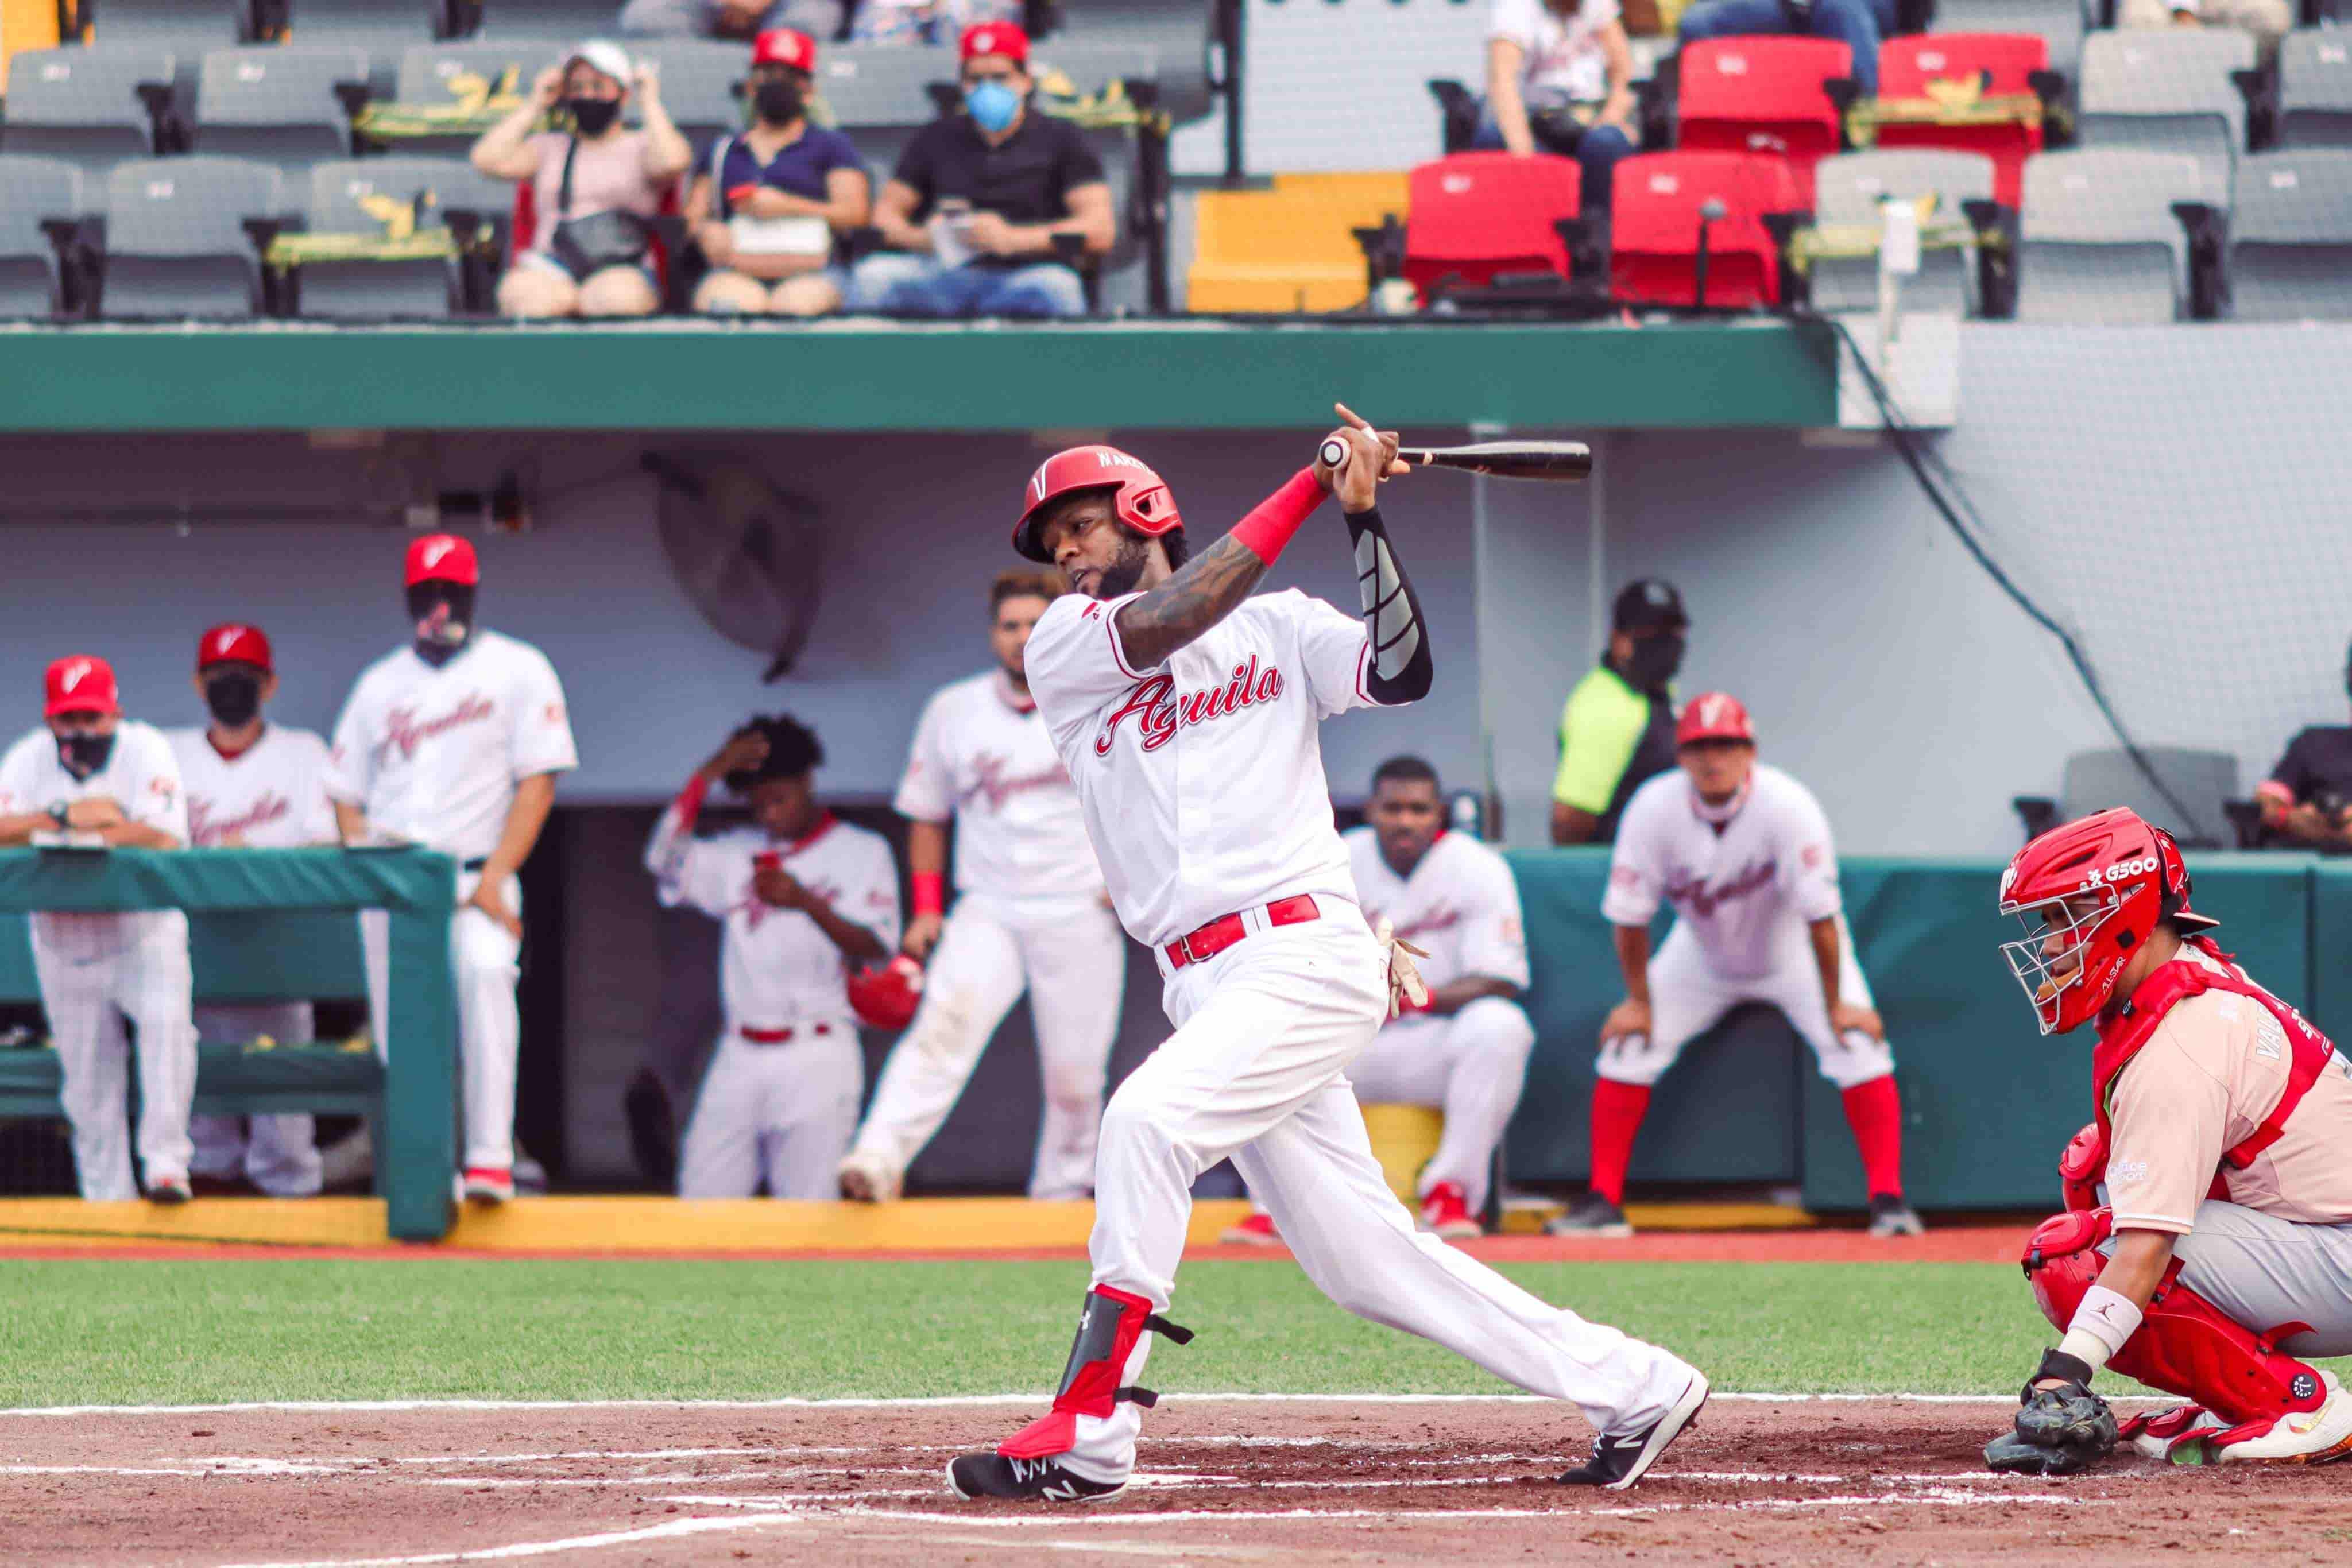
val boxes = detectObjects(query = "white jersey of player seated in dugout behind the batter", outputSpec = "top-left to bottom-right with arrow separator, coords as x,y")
1341,827 -> 1529,990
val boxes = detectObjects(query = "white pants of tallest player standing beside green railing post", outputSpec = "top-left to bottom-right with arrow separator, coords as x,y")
360,872 -> 522,1171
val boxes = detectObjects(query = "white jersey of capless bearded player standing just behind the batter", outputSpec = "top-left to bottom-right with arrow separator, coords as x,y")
891,670 -> 1103,898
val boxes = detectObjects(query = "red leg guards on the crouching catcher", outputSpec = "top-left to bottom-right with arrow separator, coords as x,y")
2025,1209 -> 2326,1439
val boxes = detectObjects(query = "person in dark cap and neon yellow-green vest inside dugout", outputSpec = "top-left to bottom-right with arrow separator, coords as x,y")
1552,578 -> 1691,844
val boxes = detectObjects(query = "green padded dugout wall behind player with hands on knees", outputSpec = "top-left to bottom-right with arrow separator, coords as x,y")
1505,849 -> 2352,1209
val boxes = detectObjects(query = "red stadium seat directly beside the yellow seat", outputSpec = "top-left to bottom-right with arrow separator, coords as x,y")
1404,153 -> 1583,299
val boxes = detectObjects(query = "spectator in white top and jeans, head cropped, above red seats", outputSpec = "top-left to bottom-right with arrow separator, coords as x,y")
1472,0 -> 1637,212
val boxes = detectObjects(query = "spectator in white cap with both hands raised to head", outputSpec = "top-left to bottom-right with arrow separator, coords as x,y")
473,38 -> 694,318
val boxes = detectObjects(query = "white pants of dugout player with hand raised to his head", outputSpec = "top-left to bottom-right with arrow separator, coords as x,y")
678,1018 -> 865,1199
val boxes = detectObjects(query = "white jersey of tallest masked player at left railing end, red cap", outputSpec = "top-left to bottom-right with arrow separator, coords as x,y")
327,630 -> 579,861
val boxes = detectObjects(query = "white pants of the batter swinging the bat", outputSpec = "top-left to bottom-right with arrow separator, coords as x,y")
1070,898 -> 1693,1481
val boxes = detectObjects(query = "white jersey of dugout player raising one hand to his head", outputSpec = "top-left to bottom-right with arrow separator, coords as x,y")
644,802 -> 899,1029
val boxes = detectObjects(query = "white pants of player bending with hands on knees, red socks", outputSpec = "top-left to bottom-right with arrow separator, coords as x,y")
1599,915 -> 1895,1089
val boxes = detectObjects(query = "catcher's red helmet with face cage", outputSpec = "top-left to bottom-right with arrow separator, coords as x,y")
2002,806 -> 2221,1035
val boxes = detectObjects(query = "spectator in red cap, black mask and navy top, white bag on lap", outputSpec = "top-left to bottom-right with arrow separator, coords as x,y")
687,28 -> 871,315
